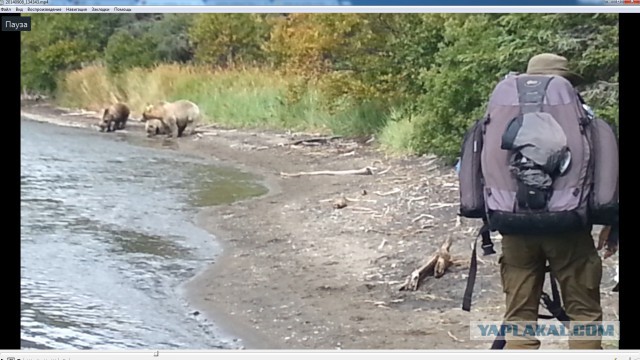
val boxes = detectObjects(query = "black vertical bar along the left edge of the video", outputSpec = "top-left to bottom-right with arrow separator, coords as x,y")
0,14 -> 20,350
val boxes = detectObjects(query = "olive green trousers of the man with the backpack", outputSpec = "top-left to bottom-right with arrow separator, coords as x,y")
499,230 -> 602,350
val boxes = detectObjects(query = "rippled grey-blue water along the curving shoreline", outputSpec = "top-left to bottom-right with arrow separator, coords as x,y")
21,121 -> 264,349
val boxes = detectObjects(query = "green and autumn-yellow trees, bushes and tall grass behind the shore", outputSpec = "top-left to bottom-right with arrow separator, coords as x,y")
22,14 -> 618,158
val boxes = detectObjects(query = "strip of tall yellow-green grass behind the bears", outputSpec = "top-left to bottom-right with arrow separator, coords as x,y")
56,65 -> 408,152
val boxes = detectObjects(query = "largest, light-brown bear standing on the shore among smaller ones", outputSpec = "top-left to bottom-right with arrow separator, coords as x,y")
142,100 -> 201,137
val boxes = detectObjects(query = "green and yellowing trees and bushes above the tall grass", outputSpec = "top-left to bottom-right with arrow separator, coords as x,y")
22,14 -> 618,157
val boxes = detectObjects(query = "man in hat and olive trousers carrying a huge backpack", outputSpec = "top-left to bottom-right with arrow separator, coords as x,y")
459,54 -> 618,349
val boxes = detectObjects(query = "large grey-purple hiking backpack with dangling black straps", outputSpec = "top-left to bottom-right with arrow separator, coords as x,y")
458,74 -> 619,346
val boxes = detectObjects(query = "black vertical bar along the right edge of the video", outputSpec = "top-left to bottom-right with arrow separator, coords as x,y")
618,13 -> 640,350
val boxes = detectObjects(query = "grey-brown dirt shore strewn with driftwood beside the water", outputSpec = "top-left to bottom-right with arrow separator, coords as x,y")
23,104 -> 618,349
